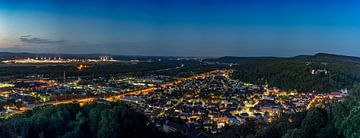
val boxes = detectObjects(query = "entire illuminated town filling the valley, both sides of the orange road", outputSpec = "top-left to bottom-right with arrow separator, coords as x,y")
0,65 -> 346,133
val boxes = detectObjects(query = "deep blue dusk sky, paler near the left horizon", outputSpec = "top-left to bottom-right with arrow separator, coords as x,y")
0,0 -> 360,57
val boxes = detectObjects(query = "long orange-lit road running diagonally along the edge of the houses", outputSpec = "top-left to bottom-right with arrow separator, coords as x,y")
20,70 -> 220,112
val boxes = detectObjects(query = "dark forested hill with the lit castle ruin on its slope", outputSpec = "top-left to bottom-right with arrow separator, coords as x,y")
207,53 -> 360,92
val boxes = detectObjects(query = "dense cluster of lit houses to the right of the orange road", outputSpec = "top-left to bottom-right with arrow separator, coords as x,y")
122,70 -> 345,133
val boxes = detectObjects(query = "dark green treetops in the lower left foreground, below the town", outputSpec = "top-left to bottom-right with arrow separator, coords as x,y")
0,103 -> 174,138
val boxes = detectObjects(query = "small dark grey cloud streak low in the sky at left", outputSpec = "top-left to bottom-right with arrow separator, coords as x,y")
20,35 -> 66,44
